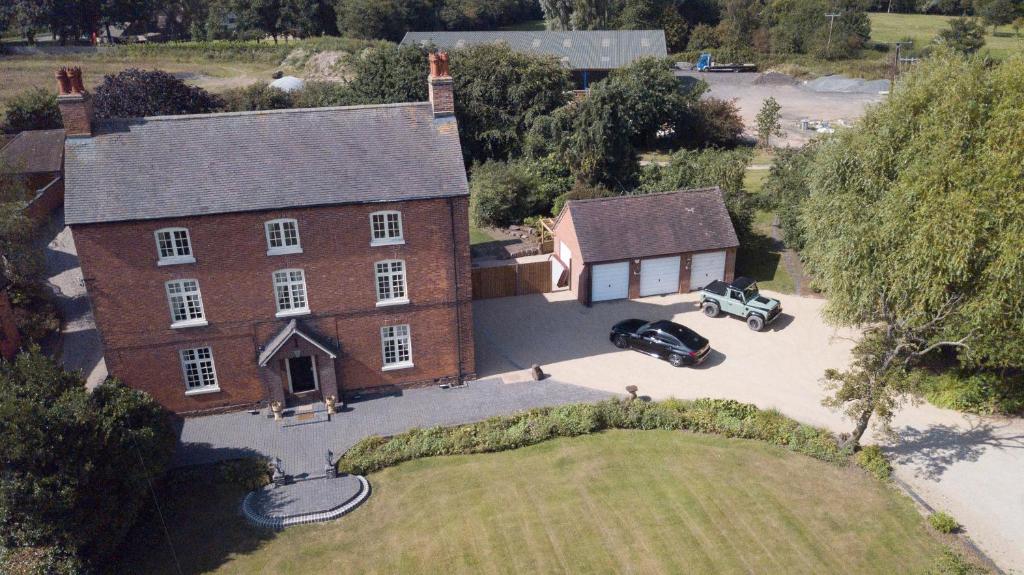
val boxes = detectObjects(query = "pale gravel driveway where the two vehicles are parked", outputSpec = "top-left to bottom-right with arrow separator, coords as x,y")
473,292 -> 1024,573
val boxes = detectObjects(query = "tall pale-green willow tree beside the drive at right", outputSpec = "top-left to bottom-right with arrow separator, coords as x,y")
802,52 -> 1024,442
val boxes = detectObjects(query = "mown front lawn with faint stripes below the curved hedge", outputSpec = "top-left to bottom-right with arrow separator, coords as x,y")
119,431 -> 942,574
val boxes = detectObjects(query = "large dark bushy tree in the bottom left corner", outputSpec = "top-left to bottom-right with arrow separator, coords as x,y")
0,348 -> 175,573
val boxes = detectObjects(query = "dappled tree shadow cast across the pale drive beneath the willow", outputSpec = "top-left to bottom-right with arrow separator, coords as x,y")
886,419 -> 1024,481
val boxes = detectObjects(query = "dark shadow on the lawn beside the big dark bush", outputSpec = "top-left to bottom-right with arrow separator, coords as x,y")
104,448 -> 276,574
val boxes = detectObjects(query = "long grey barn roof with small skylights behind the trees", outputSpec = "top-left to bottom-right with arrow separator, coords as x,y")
401,30 -> 668,70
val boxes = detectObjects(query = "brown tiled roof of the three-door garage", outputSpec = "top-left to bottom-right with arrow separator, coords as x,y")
556,187 -> 739,263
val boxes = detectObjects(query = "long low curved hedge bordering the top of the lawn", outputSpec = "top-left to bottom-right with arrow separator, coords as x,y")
338,399 -> 850,475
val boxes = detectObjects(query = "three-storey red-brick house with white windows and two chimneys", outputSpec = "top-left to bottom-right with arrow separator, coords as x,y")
58,54 -> 474,413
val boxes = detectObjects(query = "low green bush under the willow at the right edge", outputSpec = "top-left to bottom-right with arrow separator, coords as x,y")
915,370 -> 1024,415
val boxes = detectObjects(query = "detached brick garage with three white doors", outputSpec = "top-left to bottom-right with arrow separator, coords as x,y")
552,187 -> 739,305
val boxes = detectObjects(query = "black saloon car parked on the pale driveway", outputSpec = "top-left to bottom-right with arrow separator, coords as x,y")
611,319 -> 711,367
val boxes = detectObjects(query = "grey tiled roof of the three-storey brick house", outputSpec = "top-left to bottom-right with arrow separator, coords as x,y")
65,102 -> 469,224
